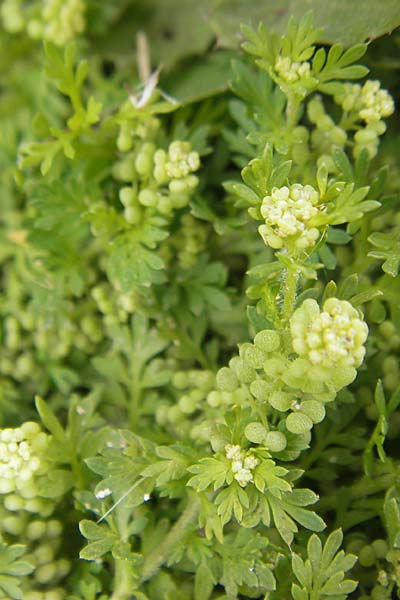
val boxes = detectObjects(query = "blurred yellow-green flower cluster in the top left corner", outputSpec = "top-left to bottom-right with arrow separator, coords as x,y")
1,0 -> 86,46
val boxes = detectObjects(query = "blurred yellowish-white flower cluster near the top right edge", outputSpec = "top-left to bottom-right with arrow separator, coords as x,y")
335,80 -> 394,124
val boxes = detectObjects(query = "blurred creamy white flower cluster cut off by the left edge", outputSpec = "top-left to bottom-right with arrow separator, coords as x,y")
0,421 -> 49,497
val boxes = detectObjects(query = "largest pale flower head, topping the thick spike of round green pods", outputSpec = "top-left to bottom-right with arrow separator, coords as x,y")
290,298 -> 368,369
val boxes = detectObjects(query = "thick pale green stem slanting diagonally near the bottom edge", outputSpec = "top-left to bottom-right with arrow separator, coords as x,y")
141,496 -> 200,583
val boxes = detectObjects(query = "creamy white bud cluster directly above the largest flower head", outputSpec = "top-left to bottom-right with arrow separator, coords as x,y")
258,183 -> 319,248
